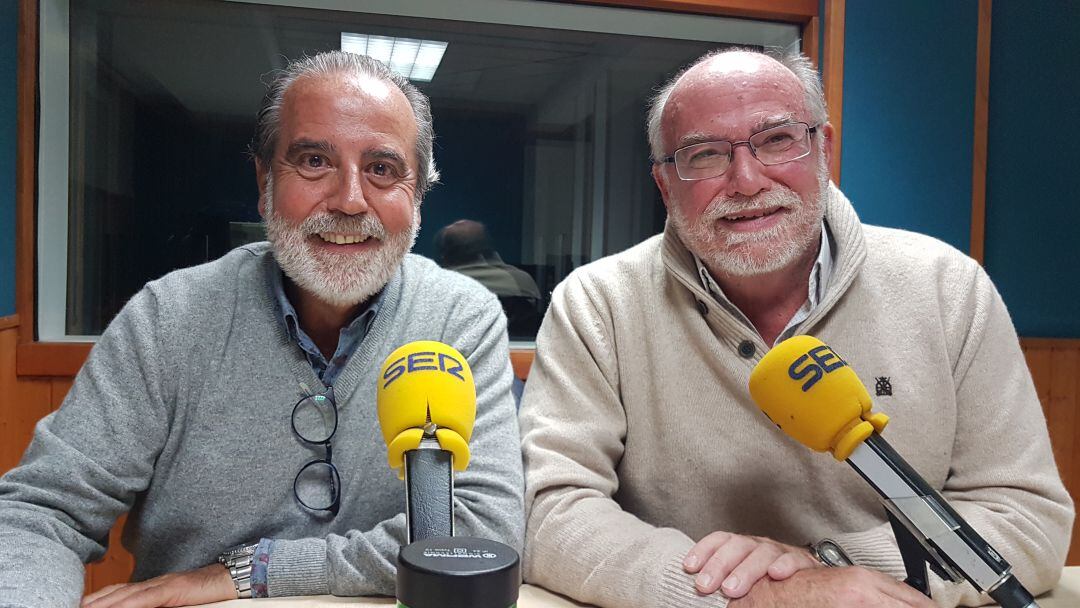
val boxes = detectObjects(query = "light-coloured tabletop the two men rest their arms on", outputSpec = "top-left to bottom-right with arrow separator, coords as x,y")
212,566 -> 1080,608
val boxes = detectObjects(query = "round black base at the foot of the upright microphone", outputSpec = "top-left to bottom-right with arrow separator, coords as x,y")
397,537 -> 521,608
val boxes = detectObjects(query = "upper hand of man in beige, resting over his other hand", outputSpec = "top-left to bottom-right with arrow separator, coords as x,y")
683,532 -> 821,598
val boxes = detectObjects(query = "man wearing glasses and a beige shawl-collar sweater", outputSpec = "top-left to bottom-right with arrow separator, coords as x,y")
522,51 -> 1074,608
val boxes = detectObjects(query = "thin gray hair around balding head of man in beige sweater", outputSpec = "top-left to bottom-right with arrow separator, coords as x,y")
646,48 -> 828,162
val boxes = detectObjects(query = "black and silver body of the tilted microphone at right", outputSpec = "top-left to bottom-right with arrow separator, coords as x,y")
847,432 -> 1038,608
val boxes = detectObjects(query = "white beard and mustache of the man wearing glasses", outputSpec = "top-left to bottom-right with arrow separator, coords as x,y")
667,154 -> 828,276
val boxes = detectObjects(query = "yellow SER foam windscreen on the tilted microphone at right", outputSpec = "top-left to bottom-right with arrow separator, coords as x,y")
750,336 -> 889,460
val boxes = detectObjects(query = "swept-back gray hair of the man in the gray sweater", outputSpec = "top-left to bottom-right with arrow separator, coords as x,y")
251,51 -> 438,203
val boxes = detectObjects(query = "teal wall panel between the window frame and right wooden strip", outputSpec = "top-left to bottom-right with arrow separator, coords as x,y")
840,0 -> 978,252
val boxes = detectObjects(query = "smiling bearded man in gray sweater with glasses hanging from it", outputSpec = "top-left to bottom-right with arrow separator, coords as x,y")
0,52 -> 524,608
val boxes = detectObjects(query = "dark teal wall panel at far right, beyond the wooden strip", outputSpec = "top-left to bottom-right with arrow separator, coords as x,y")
985,0 -> 1080,338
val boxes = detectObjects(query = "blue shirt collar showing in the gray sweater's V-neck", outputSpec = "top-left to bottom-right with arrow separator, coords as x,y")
270,265 -> 383,387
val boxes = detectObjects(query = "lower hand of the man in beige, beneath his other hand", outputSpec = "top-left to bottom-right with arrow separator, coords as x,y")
728,566 -> 937,608
